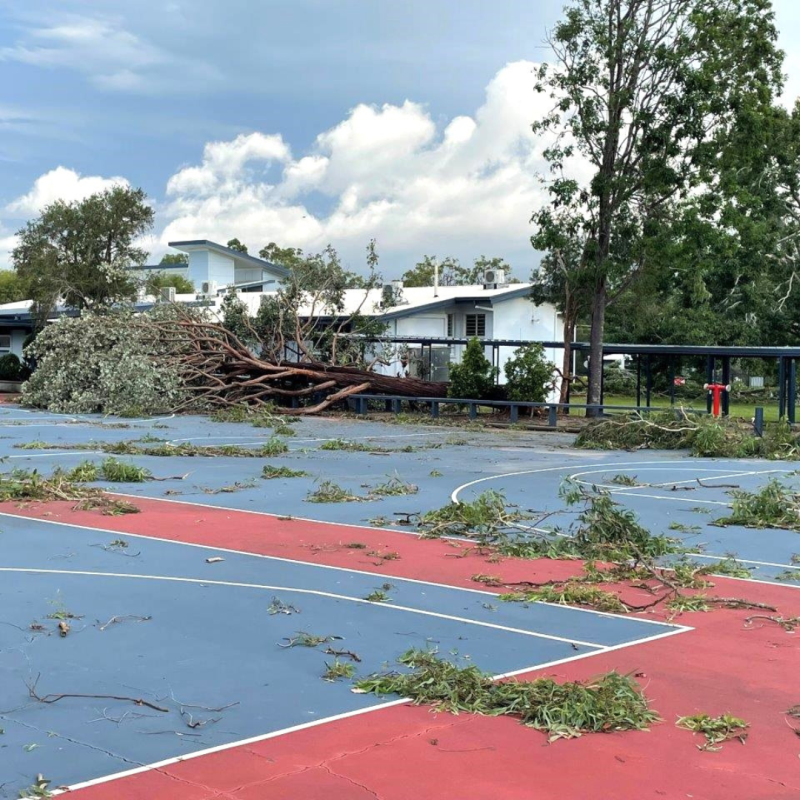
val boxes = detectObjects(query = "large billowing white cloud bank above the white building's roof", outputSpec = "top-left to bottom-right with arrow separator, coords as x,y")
161,62 -> 572,276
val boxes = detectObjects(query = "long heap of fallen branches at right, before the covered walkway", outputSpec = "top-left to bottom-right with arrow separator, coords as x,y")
575,409 -> 800,460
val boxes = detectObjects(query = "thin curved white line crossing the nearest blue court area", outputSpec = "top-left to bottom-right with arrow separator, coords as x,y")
0,567 -> 605,648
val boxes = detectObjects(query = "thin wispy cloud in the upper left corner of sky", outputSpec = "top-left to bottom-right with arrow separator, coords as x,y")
0,16 -> 218,93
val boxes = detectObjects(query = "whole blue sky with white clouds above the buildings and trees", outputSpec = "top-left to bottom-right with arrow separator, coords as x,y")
0,0 -> 800,277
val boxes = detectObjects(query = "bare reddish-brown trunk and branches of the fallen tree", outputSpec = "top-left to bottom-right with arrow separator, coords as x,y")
141,307 -> 447,414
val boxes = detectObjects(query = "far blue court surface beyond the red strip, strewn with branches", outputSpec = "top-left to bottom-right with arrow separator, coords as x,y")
0,408 -> 800,585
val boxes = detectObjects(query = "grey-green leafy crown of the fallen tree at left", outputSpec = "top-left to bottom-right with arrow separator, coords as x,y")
22,313 -> 184,416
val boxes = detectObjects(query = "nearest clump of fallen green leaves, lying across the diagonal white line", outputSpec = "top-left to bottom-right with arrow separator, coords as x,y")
356,650 -> 659,740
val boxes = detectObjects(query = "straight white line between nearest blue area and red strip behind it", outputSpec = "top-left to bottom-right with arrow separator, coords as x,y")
0,510 -> 680,628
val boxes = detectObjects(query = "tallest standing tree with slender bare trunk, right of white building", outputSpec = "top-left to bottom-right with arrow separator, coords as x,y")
533,0 -> 782,416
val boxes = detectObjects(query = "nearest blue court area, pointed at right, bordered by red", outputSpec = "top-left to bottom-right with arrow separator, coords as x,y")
0,516 -> 687,797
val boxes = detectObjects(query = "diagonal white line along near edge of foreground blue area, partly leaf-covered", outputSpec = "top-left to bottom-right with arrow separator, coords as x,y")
53,627 -> 694,796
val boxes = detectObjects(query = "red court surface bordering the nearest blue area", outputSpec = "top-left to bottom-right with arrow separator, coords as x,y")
8,498 -> 800,800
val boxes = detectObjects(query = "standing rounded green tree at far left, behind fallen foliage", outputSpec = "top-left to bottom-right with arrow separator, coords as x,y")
12,186 -> 153,319
